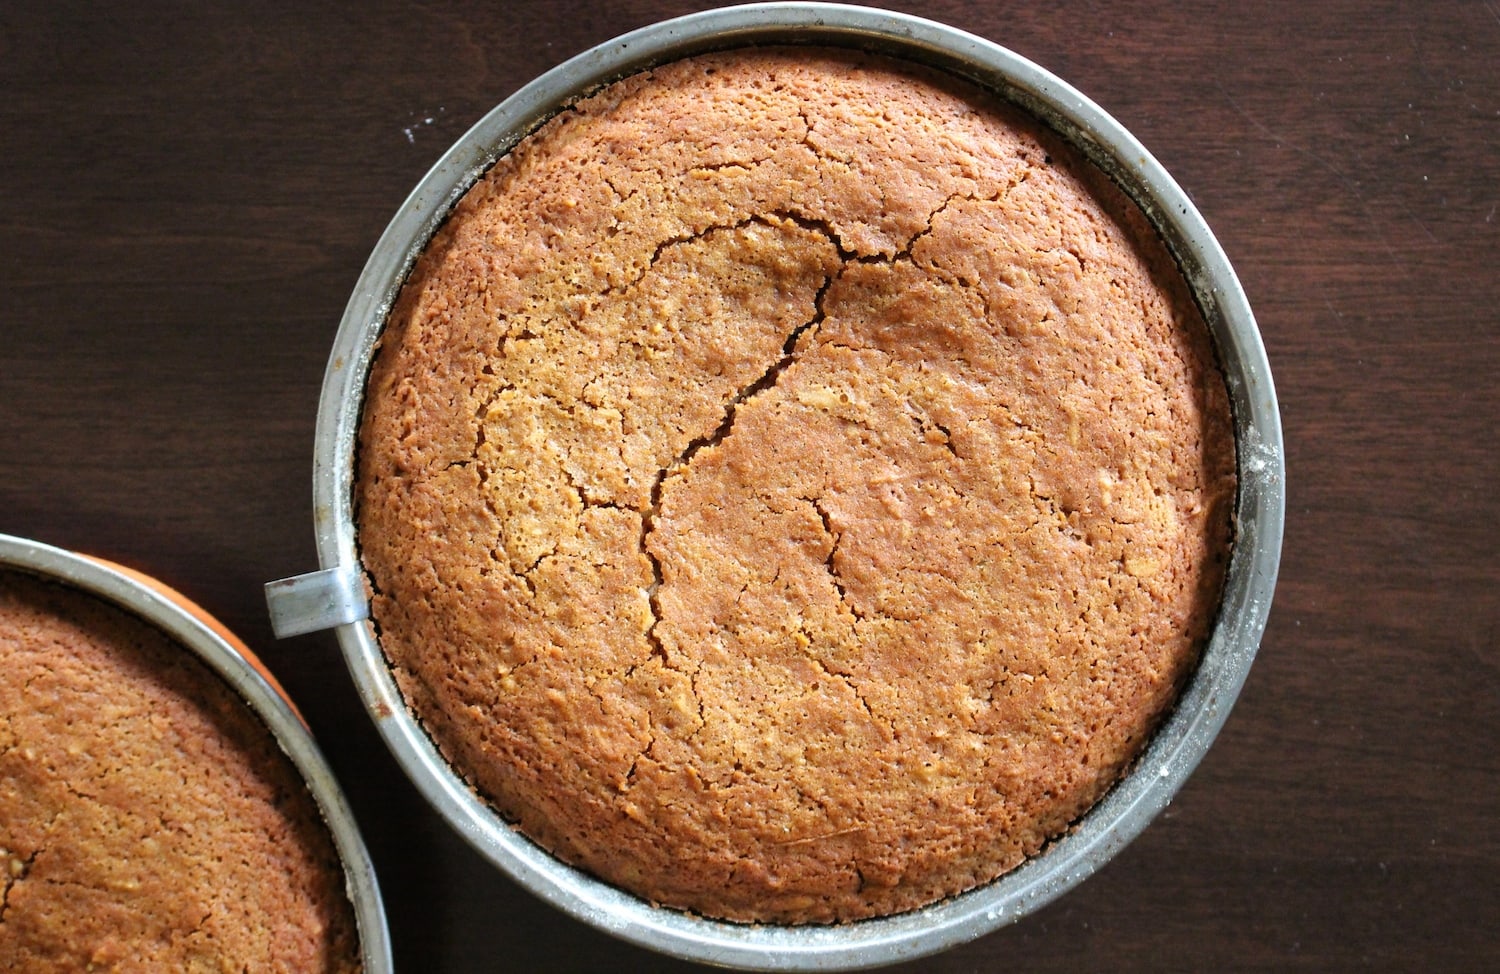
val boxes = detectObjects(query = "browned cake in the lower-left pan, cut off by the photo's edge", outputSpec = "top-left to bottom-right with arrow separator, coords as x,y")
0,572 -> 360,974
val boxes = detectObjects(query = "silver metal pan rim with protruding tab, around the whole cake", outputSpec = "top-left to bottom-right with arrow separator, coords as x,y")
267,3 -> 1284,969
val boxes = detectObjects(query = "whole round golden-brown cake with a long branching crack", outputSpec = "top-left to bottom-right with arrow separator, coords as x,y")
356,51 -> 1235,923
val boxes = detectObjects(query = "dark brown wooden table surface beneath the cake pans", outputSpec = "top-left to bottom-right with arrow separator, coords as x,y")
0,0 -> 1500,971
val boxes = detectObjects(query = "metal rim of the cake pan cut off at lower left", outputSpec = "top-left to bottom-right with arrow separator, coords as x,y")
0,534 -> 393,974
